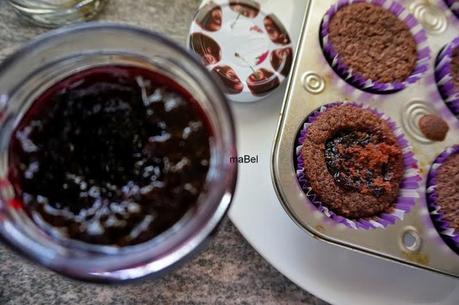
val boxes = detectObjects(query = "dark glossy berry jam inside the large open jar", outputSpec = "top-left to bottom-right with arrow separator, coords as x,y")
10,66 -> 212,246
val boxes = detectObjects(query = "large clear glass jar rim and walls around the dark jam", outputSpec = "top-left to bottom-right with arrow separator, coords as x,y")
0,23 -> 237,282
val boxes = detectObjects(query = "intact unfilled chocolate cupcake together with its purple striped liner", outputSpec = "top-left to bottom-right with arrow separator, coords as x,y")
321,0 -> 430,93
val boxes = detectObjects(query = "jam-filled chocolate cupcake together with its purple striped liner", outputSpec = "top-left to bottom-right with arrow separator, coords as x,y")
296,103 -> 420,229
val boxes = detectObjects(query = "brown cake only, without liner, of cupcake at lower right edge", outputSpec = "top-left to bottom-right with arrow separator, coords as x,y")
436,154 -> 459,232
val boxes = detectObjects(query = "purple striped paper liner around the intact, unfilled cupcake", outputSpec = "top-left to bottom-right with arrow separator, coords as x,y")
320,0 -> 431,94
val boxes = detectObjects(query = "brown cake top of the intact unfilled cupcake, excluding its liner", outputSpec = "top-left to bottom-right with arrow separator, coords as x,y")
329,3 -> 417,83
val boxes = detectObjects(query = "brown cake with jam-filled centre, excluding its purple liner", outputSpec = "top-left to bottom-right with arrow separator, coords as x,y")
301,104 -> 404,219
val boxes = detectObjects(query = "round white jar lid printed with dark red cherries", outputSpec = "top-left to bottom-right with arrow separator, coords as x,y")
188,0 -> 293,102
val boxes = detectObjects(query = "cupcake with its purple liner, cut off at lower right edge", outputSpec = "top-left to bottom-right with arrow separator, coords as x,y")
427,145 -> 459,253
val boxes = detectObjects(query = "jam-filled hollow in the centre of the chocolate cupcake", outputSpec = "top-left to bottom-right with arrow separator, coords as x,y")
325,130 -> 400,197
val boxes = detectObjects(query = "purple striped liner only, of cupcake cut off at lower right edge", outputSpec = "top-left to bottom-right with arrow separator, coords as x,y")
426,145 -> 459,253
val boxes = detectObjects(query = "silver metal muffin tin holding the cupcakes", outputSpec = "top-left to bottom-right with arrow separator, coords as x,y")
272,0 -> 459,277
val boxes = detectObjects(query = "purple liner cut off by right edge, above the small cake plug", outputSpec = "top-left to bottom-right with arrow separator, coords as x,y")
435,36 -> 459,118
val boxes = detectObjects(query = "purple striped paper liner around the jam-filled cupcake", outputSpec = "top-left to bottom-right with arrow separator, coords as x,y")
295,102 -> 421,230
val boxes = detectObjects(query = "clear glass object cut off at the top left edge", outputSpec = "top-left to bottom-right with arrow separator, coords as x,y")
8,0 -> 108,27
